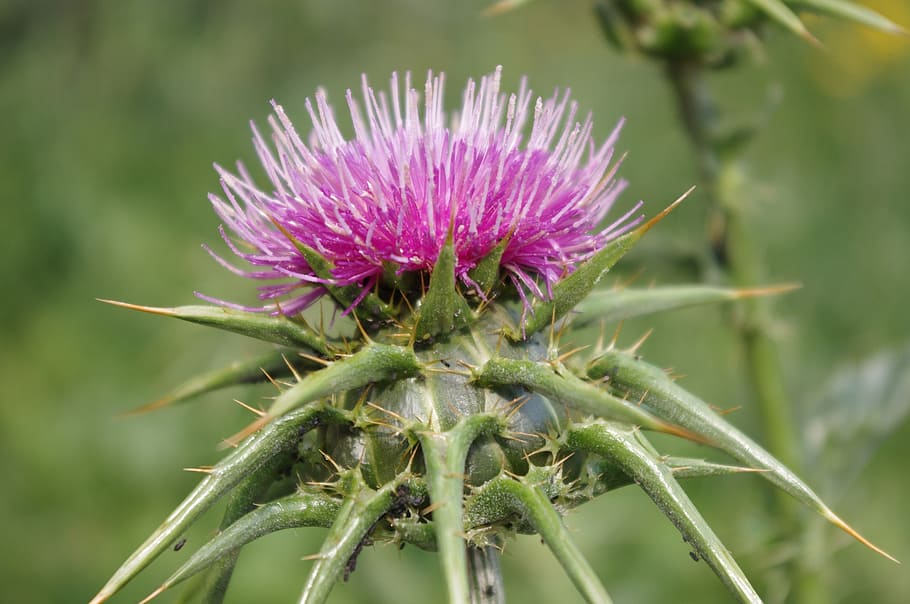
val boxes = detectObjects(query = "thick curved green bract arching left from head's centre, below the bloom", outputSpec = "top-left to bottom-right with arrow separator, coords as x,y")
228,342 -> 420,444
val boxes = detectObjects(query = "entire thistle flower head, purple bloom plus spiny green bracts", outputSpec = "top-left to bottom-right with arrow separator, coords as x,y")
93,70 -> 896,604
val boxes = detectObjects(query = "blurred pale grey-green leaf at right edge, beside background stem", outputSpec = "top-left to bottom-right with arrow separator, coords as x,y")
805,344 -> 910,497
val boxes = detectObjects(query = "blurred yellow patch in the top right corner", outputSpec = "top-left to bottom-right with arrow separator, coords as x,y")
807,0 -> 910,98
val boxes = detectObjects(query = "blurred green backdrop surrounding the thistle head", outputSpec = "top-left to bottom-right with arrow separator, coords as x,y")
0,0 -> 910,604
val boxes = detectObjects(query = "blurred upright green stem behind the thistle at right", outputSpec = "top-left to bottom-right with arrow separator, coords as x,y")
667,61 -> 825,602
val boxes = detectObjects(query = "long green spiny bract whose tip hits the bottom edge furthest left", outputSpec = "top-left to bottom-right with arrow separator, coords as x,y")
90,404 -> 346,604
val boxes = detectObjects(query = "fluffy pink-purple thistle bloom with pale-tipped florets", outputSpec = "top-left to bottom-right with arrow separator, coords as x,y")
197,68 -> 641,315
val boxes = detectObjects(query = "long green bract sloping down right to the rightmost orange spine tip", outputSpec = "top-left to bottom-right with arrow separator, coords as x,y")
588,350 -> 897,562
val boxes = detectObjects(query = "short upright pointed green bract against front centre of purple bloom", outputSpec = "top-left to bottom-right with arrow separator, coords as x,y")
414,231 -> 470,342
